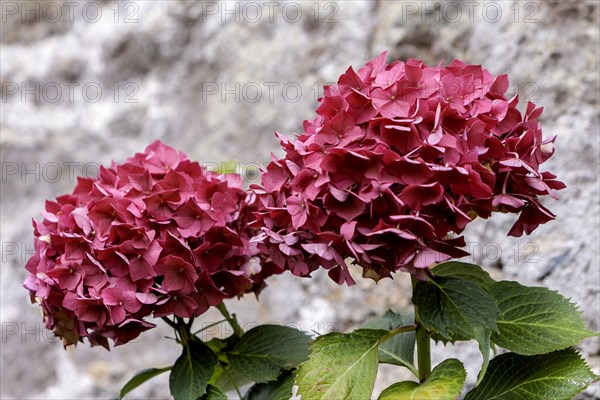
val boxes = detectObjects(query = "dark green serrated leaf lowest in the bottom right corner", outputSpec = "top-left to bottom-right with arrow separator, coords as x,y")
465,348 -> 598,400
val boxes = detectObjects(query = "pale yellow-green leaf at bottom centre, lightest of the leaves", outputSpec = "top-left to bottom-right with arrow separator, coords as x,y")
295,329 -> 388,400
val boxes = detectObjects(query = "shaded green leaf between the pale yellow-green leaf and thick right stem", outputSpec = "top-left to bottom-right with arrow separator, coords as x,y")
361,310 -> 417,373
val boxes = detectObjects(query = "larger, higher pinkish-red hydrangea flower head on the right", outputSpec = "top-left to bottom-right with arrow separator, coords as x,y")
253,53 -> 564,284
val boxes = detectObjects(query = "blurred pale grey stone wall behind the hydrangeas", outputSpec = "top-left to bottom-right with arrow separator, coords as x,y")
0,0 -> 600,399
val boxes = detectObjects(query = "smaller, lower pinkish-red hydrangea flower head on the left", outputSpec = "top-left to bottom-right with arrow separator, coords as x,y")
24,141 -> 277,348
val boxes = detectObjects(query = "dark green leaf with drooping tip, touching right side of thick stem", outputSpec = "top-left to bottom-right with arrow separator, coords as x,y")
413,276 -> 500,379
